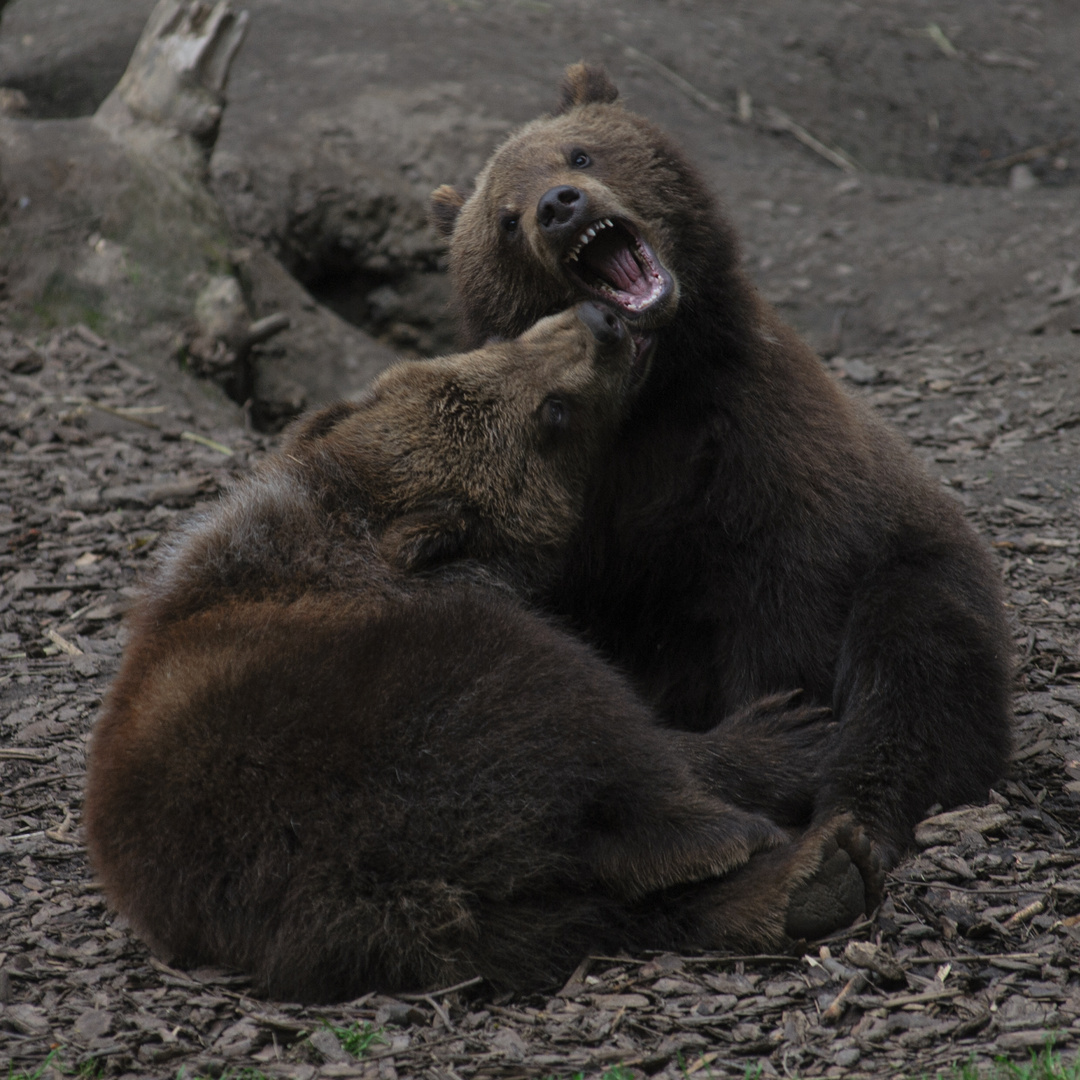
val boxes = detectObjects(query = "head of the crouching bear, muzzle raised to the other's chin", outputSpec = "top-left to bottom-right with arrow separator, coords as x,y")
284,302 -> 650,580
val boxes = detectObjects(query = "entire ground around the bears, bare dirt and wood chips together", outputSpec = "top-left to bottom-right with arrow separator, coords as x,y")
0,0 -> 1080,1080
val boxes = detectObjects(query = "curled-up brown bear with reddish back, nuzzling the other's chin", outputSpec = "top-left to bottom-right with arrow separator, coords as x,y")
85,303 -> 879,1001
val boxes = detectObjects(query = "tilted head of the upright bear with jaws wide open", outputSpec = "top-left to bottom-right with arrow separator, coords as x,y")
431,64 -> 714,343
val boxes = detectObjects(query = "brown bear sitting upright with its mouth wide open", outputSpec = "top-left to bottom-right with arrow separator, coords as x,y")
432,65 -> 1013,863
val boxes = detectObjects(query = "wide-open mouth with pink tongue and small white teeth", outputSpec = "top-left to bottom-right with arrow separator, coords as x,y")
566,217 -> 672,315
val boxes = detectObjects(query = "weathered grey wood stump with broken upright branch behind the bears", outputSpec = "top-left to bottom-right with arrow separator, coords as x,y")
0,0 -> 392,427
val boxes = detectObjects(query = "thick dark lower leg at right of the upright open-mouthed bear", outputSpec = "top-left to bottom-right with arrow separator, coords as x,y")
815,558 -> 1012,865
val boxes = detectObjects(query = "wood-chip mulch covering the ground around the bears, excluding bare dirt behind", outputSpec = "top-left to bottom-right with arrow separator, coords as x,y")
0,323 -> 1080,1080
